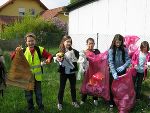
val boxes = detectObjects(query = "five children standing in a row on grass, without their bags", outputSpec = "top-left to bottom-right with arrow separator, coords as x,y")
0,33 -> 150,112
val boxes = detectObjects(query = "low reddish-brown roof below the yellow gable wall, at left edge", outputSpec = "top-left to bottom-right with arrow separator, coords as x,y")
0,15 -> 22,24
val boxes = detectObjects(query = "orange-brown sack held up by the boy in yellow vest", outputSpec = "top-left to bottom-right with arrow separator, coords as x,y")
6,49 -> 34,90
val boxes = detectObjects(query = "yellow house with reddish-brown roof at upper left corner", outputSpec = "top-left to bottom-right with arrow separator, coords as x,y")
0,0 -> 48,31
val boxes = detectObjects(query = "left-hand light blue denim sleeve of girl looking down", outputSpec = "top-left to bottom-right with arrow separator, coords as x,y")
108,49 -> 117,75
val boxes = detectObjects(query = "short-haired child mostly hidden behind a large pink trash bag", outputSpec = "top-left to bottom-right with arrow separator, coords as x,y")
80,38 -> 100,106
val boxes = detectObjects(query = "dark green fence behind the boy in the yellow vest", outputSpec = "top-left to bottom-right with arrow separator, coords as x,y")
0,33 -> 62,51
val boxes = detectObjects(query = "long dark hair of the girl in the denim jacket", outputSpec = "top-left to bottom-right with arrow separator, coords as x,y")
110,34 -> 125,62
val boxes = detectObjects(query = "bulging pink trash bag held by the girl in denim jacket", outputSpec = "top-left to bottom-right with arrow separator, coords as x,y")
111,70 -> 136,113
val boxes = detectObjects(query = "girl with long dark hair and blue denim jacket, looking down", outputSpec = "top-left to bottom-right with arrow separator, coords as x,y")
108,34 -> 130,110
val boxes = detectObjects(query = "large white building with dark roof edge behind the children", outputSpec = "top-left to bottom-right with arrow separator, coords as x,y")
66,0 -> 150,52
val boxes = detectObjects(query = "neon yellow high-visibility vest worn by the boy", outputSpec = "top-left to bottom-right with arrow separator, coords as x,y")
24,46 -> 44,81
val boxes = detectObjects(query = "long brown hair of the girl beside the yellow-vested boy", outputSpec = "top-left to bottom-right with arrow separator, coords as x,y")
59,35 -> 72,53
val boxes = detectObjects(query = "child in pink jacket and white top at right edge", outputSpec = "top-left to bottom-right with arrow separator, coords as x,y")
132,41 -> 150,100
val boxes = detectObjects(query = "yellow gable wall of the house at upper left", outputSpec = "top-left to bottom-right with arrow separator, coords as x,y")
0,0 -> 44,16
